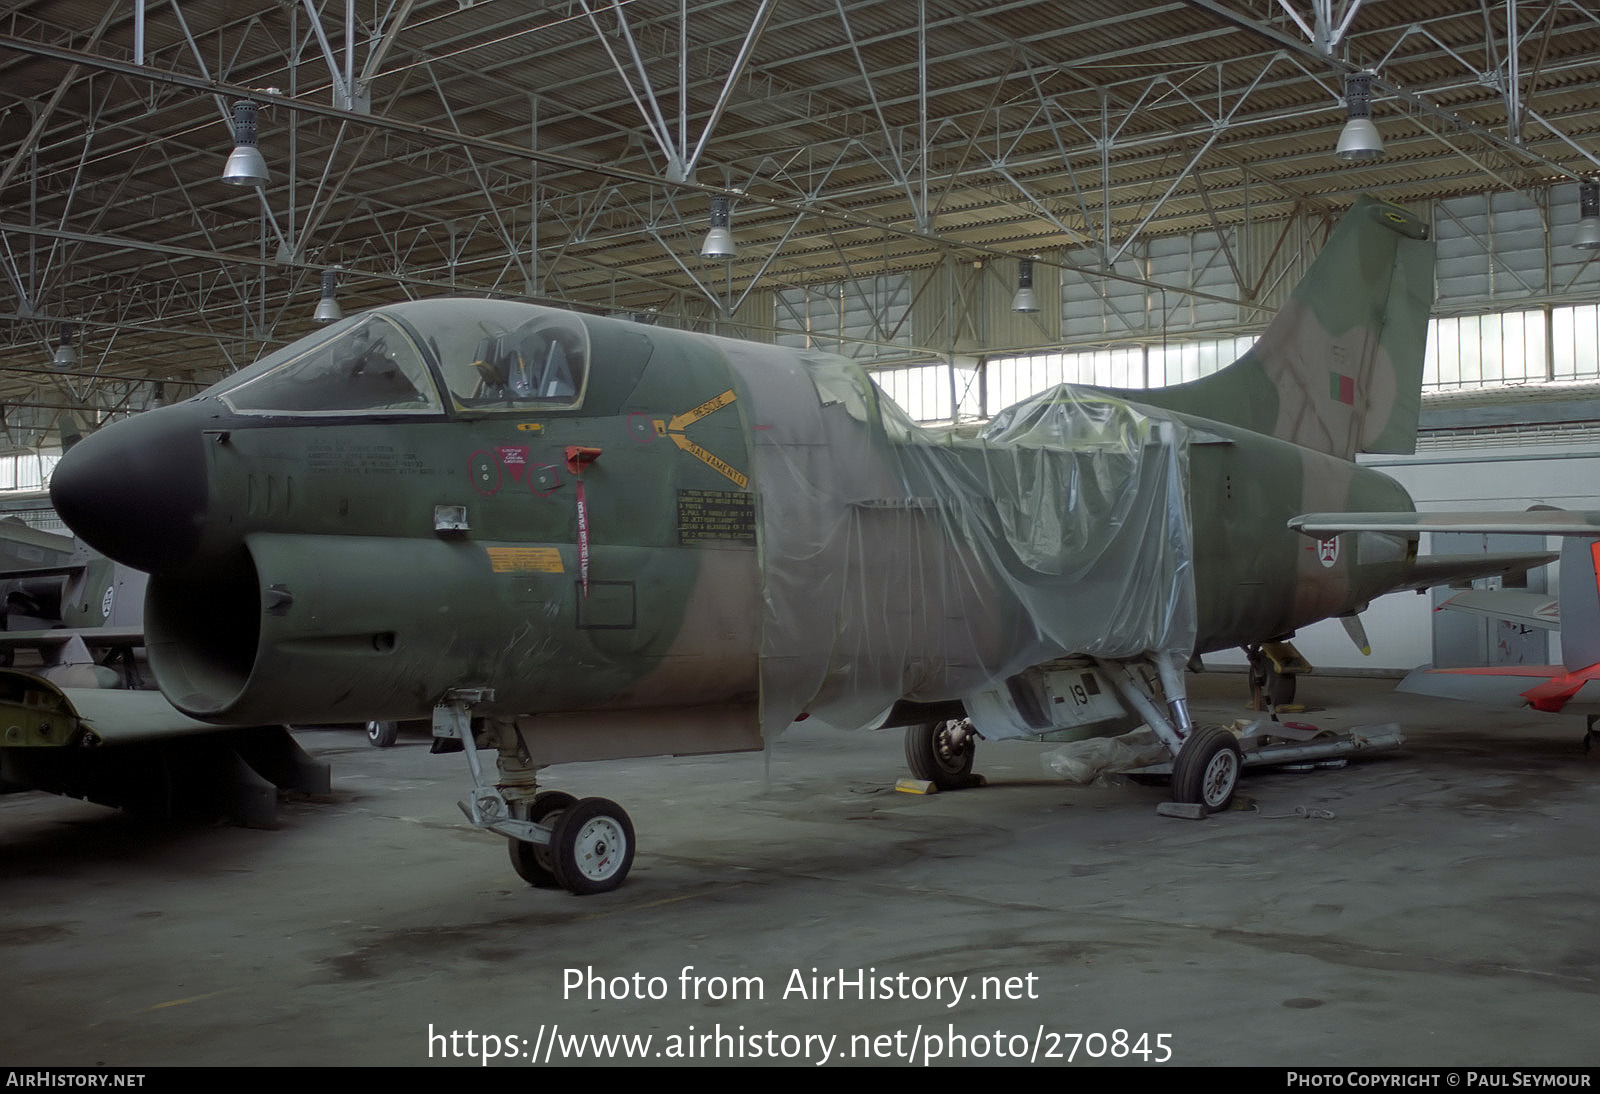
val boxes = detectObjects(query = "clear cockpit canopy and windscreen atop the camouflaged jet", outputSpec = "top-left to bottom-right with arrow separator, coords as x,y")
211,299 -> 590,416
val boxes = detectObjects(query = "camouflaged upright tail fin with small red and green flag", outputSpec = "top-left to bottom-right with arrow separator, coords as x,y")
1125,197 -> 1434,459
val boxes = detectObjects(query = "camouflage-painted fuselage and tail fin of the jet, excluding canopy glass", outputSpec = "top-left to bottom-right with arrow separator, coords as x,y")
53,194 -> 1465,742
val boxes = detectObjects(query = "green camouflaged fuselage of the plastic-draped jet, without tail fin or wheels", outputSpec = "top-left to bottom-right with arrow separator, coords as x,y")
54,297 -> 1411,735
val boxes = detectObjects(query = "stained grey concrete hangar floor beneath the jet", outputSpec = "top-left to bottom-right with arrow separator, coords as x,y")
0,675 -> 1600,1065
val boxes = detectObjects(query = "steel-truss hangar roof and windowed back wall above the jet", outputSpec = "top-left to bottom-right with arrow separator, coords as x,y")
0,0 -> 1600,669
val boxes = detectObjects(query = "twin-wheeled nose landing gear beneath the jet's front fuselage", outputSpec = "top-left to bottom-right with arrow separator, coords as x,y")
434,689 -> 635,896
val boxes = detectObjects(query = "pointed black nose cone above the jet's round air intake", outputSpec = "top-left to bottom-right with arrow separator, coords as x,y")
50,405 -> 206,573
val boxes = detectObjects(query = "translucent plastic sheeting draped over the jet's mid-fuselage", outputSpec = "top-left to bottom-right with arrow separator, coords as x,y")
726,345 -> 1195,731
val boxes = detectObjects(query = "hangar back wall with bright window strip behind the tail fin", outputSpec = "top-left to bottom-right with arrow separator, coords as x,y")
768,184 -> 1600,431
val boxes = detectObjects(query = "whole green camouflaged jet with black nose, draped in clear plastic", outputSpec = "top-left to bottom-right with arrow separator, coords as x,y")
51,198 -> 1561,892
